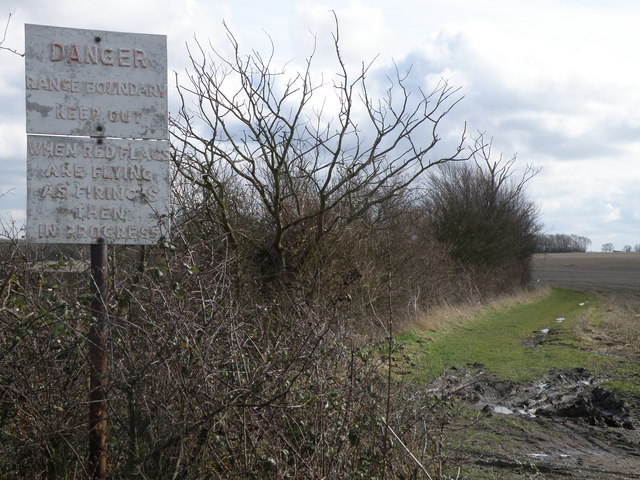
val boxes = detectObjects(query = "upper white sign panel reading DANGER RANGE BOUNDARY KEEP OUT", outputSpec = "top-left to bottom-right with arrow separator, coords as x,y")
25,25 -> 168,139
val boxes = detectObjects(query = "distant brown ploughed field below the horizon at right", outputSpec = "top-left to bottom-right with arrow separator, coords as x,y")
532,252 -> 640,298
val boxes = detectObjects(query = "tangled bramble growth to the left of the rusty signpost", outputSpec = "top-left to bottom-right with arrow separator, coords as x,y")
0,242 -> 88,478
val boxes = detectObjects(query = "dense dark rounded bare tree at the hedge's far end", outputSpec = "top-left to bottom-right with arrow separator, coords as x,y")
426,135 -> 540,292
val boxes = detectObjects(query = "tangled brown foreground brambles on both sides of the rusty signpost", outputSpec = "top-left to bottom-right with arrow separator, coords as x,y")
0,234 -> 460,479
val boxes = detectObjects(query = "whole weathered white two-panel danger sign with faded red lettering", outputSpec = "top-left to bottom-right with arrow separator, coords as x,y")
25,25 -> 170,244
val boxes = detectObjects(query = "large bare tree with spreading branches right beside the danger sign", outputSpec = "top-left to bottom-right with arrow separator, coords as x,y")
173,16 -> 469,284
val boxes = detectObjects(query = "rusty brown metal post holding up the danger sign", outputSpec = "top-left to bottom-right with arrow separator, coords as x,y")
89,239 -> 109,480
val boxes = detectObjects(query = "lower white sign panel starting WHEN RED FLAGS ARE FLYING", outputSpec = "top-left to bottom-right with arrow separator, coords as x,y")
26,135 -> 170,244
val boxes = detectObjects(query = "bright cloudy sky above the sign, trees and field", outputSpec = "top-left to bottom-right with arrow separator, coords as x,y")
0,0 -> 640,251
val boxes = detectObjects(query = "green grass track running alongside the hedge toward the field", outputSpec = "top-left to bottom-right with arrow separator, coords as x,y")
395,289 -> 640,392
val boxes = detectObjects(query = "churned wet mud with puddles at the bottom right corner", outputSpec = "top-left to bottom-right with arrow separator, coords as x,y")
431,364 -> 640,480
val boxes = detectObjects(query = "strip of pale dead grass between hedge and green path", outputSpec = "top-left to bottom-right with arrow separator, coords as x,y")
408,287 -> 550,332
